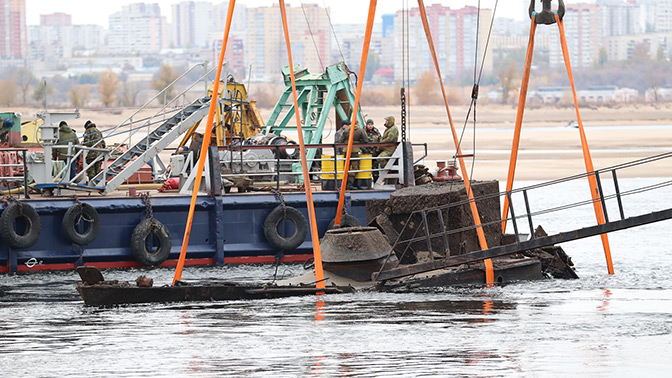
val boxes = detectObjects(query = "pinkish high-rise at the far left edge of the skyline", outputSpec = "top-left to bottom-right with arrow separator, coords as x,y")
0,0 -> 28,59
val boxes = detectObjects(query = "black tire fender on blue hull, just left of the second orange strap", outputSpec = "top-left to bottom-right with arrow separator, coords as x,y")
264,206 -> 308,251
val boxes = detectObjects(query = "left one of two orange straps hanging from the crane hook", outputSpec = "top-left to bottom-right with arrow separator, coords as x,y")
502,16 -> 537,234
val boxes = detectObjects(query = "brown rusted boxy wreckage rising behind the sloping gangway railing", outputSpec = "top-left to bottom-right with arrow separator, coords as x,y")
366,181 -> 578,278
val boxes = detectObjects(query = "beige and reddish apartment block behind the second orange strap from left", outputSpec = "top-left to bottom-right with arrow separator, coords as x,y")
245,4 -> 332,80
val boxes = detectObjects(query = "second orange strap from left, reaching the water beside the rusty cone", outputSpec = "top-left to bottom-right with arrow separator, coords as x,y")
279,0 -> 326,289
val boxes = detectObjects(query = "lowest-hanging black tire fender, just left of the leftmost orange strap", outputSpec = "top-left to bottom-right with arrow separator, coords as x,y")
131,218 -> 172,266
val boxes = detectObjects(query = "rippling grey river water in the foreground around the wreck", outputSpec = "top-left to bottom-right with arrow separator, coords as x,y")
0,179 -> 672,377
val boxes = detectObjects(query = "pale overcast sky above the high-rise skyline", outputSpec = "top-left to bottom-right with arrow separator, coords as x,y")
26,0 -> 593,28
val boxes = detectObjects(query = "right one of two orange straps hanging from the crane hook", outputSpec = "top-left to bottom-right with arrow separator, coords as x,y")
555,13 -> 614,274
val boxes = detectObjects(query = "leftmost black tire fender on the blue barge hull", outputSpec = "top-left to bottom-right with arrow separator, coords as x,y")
0,202 -> 42,249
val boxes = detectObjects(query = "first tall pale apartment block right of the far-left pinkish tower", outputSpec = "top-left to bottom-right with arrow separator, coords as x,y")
108,3 -> 168,53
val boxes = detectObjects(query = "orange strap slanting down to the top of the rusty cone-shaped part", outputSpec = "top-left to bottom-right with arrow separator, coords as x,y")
334,0 -> 377,226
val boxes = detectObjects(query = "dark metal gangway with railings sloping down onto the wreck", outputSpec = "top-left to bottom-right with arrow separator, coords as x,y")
372,152 -> 672,281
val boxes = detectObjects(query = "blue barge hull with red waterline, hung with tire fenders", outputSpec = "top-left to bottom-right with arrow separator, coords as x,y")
0,190 -> 391,273
